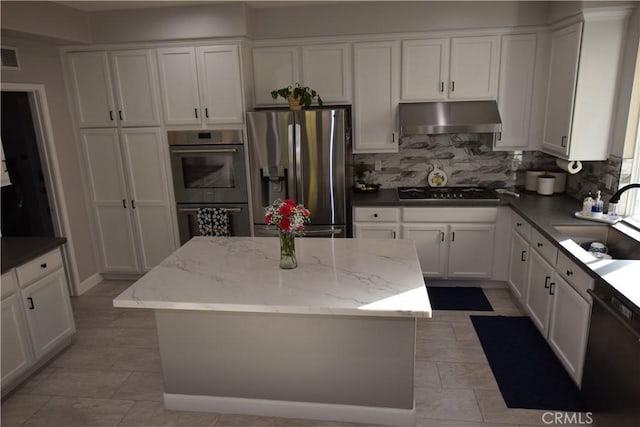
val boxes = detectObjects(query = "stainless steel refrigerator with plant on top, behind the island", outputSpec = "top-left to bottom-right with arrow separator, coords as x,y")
247,108 -> 351,237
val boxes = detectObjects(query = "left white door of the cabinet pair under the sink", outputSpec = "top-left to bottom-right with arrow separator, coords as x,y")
525,250 -> 554,337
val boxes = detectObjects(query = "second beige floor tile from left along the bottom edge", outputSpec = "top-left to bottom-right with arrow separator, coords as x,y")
24,397 -> 133,427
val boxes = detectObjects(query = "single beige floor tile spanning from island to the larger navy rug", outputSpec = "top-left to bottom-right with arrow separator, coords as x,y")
416,340 -> 487,363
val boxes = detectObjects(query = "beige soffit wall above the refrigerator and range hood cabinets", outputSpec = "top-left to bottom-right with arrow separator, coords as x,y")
249,1 -> 549,39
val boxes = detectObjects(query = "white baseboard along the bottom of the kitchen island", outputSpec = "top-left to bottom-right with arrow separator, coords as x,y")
164,393 -> 416,427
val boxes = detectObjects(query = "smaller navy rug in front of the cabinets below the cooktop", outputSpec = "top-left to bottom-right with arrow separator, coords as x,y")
427,286 -> 493,311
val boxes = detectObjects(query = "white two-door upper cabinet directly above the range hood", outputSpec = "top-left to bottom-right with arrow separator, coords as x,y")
401,36 -> 499,101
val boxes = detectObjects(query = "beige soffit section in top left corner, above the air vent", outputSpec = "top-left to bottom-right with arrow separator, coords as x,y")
0,1 -> 91,43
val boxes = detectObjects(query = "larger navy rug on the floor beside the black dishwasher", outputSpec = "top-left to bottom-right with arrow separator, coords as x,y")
470,316 -> 584,412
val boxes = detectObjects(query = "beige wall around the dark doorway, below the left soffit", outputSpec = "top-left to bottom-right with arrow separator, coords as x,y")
2,35 -> 98,282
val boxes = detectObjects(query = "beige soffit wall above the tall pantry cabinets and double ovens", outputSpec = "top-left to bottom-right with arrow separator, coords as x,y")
89,4 -> 247,43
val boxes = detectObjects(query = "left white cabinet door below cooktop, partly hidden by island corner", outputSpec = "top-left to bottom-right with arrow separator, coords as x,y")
402,223 -> 448,277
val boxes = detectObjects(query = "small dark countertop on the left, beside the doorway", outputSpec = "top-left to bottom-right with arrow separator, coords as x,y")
0,237 -> 67,273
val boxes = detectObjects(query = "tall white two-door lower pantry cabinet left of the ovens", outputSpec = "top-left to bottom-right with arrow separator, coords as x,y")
81,128 -> 176,273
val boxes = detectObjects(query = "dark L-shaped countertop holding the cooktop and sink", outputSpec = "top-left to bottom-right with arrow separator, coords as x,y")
351,189 -> 640,308
